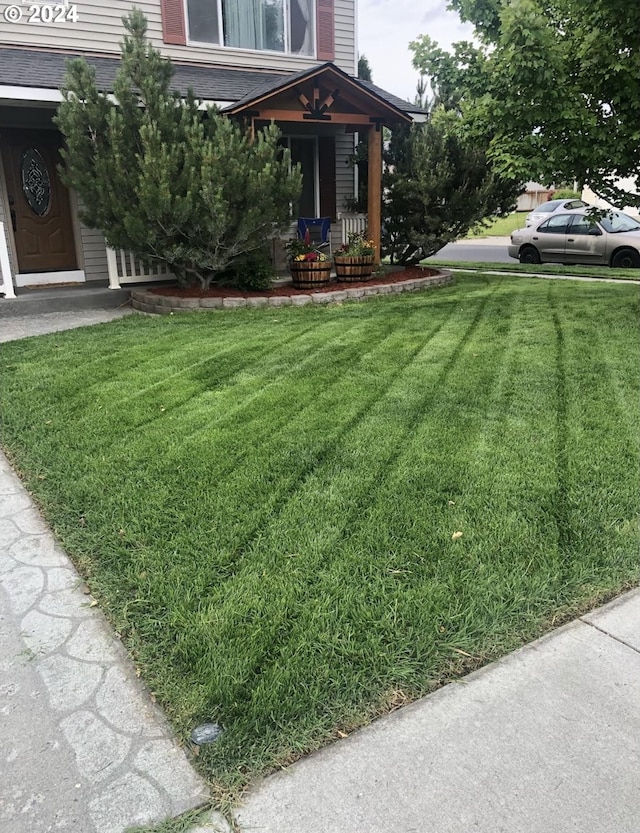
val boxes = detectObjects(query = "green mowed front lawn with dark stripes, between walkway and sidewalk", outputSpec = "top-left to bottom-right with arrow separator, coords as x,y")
0,275 -> 640,802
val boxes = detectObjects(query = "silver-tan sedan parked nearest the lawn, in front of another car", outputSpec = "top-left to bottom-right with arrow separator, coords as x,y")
509,209 -> 640,269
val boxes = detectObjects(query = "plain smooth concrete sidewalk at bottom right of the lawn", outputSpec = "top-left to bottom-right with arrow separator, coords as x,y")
237,590 -> 640,833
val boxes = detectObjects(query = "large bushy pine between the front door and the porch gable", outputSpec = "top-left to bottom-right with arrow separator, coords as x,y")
56,10 -> 301,288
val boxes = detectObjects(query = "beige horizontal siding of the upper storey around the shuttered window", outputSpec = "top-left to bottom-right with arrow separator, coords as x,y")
0,0 -> 355,75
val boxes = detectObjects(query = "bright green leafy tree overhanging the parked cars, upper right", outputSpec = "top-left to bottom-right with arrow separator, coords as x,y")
411,0 -> 640,205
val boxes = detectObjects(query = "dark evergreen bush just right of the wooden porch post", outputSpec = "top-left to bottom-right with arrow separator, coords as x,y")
382,106 -> 521,264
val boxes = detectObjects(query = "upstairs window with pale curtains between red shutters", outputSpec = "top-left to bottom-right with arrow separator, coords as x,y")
186,0 -> 315,55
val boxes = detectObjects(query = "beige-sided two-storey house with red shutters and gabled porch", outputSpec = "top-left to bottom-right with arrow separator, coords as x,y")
0,0 -> 425,291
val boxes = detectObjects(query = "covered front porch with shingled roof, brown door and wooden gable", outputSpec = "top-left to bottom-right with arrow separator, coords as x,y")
0,48 -> 426,298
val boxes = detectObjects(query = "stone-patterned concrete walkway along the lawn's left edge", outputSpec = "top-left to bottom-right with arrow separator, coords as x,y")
0,454 -> 228,833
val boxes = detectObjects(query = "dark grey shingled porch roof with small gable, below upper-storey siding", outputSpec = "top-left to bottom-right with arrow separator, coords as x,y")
0,46 -> 425,116
